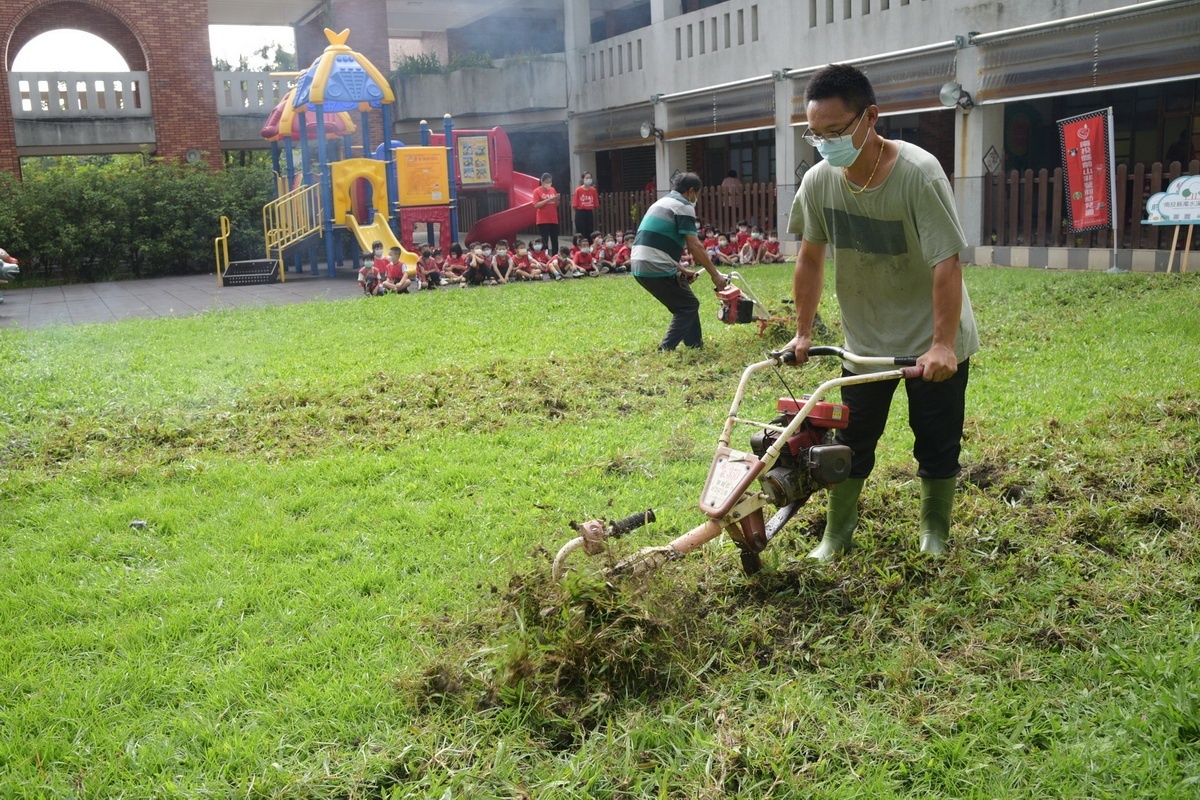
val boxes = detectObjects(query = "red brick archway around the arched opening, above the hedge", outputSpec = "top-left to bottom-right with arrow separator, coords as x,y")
0,0 -> 221,175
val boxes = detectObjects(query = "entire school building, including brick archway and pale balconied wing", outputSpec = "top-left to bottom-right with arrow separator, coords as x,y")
0,0 -> 1200,270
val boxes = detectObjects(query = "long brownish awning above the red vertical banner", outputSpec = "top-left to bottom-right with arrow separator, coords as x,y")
974,2 -> 1200,103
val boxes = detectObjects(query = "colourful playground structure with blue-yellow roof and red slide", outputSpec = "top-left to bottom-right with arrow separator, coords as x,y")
215,29 -> 549,285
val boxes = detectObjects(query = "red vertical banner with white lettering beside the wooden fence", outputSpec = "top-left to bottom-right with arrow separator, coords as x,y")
1058,108 -> 1114,233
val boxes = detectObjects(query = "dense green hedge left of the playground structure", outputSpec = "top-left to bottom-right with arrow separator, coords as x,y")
0,157 -> 274,283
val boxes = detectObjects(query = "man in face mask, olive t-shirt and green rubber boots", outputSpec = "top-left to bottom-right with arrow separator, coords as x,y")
787,64 -> 979,559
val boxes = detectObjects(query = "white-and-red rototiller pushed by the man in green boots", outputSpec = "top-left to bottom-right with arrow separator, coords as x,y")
553,347 -> 922,579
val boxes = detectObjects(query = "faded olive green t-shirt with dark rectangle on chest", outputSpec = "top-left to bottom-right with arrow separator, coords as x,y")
787,142 -> 979,373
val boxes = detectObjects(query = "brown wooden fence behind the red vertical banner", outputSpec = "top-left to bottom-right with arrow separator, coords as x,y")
983,161 -> 1200,249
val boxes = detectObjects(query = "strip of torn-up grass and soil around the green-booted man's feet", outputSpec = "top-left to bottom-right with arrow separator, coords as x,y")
396,395 -> 1200,776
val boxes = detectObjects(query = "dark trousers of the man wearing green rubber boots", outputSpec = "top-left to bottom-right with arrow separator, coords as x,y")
836,359 -> 971,479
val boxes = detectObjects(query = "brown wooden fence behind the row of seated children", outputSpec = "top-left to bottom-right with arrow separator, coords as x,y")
458,184 -> 775,237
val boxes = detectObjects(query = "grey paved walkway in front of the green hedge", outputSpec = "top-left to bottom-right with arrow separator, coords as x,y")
0,267 -> 362,327
